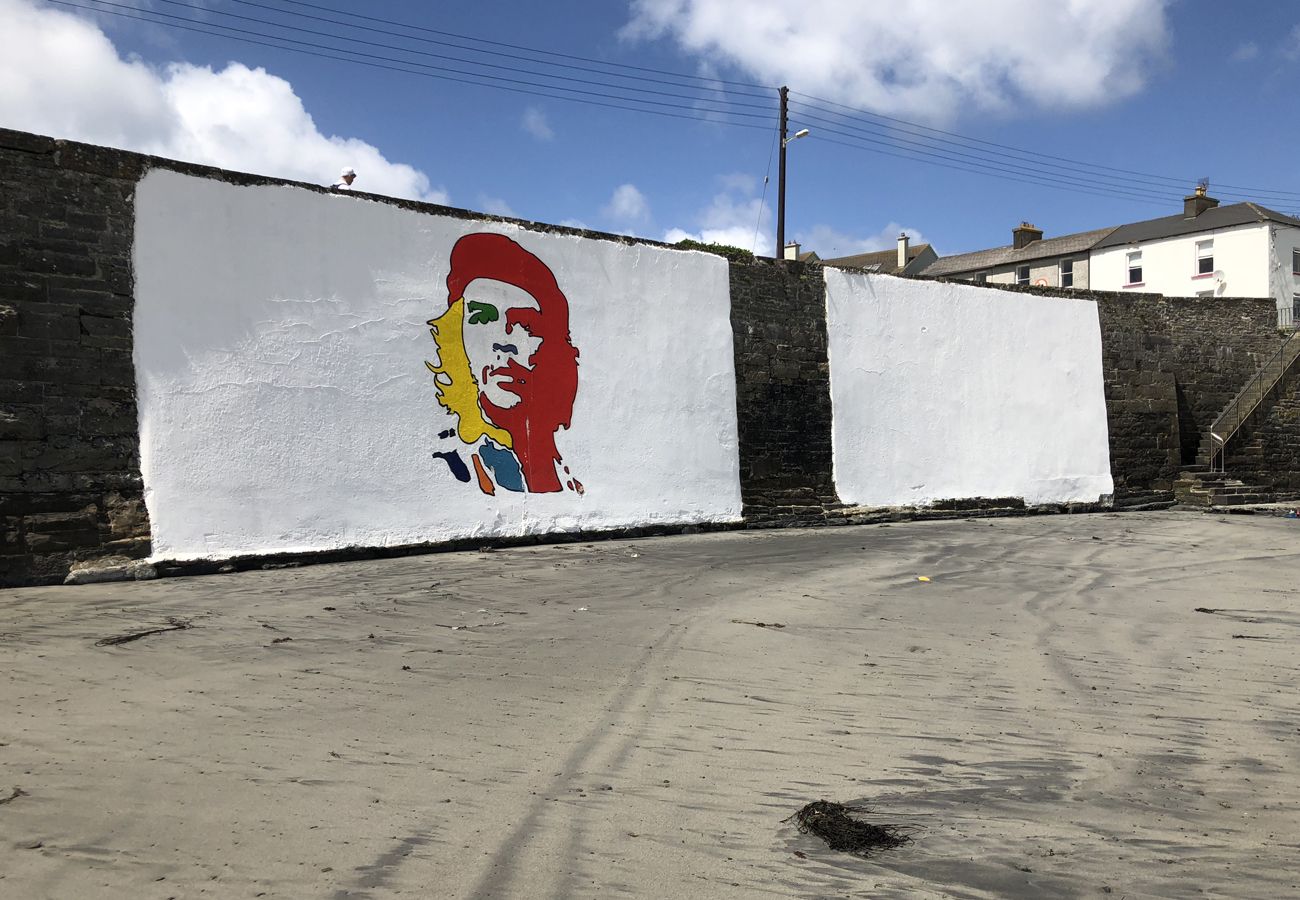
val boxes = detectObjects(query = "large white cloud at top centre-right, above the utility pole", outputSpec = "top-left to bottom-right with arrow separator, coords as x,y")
623,0 -> 1171,121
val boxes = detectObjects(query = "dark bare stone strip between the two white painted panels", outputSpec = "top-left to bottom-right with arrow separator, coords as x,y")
731,259 -> 837,524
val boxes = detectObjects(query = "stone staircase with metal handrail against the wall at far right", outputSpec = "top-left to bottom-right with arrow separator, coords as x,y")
1174,332 -> 1300,506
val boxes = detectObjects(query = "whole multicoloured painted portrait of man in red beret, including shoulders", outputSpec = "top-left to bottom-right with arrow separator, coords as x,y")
425,233 -> 585,494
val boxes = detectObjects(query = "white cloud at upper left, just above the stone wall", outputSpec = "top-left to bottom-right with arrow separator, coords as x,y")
0,0 -> 447,203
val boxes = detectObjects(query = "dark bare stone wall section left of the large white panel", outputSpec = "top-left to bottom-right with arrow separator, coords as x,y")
0,130 -> 150,584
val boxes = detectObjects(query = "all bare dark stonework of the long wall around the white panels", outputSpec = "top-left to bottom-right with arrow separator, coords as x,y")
0,130 -> 1300,585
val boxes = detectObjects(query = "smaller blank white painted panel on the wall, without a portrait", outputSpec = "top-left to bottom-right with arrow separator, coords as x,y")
826,269 -> 1114,506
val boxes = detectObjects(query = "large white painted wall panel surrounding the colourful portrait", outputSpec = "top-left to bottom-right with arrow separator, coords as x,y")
135,170 -> 741,559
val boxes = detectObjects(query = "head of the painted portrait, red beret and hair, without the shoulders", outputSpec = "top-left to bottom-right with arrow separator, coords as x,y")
429,233 -> 579,486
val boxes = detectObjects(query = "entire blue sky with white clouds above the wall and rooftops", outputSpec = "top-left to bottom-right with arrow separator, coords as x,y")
0,0 -> 1300,256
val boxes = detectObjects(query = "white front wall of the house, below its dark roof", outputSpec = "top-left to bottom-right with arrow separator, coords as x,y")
1089,224 -> 1268,297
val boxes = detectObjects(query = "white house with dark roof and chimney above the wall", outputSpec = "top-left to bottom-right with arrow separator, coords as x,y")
1089,190 -> 1300,326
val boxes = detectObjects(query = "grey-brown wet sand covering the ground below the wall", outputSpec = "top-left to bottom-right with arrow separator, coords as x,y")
0,512 -> 1300,900
